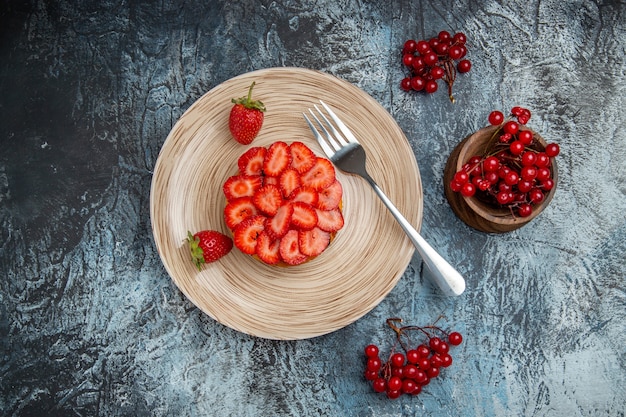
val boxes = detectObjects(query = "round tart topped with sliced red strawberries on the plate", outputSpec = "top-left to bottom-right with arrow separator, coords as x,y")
223,141 -> 344,265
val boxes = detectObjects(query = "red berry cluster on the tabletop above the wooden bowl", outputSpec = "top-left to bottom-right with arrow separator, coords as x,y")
400,30 -> 472,102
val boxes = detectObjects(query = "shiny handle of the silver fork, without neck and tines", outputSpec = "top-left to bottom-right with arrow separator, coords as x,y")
365,175 -> 465,296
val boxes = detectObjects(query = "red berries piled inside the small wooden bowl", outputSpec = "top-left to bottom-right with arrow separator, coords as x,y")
450,107 -> 560,217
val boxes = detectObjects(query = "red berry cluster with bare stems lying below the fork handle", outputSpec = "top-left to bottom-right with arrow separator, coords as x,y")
364,318 -> 463,399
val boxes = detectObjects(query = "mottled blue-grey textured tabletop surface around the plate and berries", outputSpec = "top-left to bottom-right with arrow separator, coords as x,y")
0,0 -> 626,417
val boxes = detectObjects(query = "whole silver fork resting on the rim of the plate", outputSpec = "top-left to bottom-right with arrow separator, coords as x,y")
303,100 -> 465,295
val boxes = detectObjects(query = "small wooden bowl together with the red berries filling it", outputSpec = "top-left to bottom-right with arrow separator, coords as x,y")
444,107 -> 560,233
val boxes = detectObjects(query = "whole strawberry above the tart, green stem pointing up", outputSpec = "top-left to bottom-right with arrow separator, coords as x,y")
228,82 -> 265,145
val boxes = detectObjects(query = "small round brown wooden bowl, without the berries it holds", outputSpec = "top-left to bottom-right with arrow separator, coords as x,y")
443,126 -> 558,233
